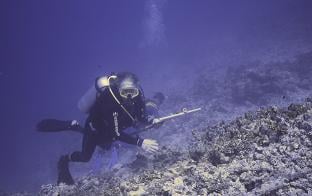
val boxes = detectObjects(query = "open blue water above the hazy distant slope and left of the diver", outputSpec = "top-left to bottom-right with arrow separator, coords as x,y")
0,0 -> 312,191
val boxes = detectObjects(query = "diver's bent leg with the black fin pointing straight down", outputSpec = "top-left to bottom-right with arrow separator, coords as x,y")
57,131 -> 96,184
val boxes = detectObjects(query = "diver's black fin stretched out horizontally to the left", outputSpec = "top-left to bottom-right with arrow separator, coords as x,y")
37,119 -> 82,132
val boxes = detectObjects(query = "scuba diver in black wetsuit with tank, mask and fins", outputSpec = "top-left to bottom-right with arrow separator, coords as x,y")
37,72 -> 165,185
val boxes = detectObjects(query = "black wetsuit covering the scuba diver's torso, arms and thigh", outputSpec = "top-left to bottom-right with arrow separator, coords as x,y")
70,86 -> 148,162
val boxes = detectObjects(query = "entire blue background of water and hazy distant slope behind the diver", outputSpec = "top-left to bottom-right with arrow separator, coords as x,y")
0,0 -> 312,194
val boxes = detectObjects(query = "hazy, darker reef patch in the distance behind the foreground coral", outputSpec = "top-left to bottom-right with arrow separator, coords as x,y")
193,51 -> 312,105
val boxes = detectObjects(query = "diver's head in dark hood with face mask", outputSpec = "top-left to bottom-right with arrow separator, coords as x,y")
117,72 -> 140,100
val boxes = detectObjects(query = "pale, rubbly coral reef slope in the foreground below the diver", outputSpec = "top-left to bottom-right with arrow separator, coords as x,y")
24,98 -> 312,195
